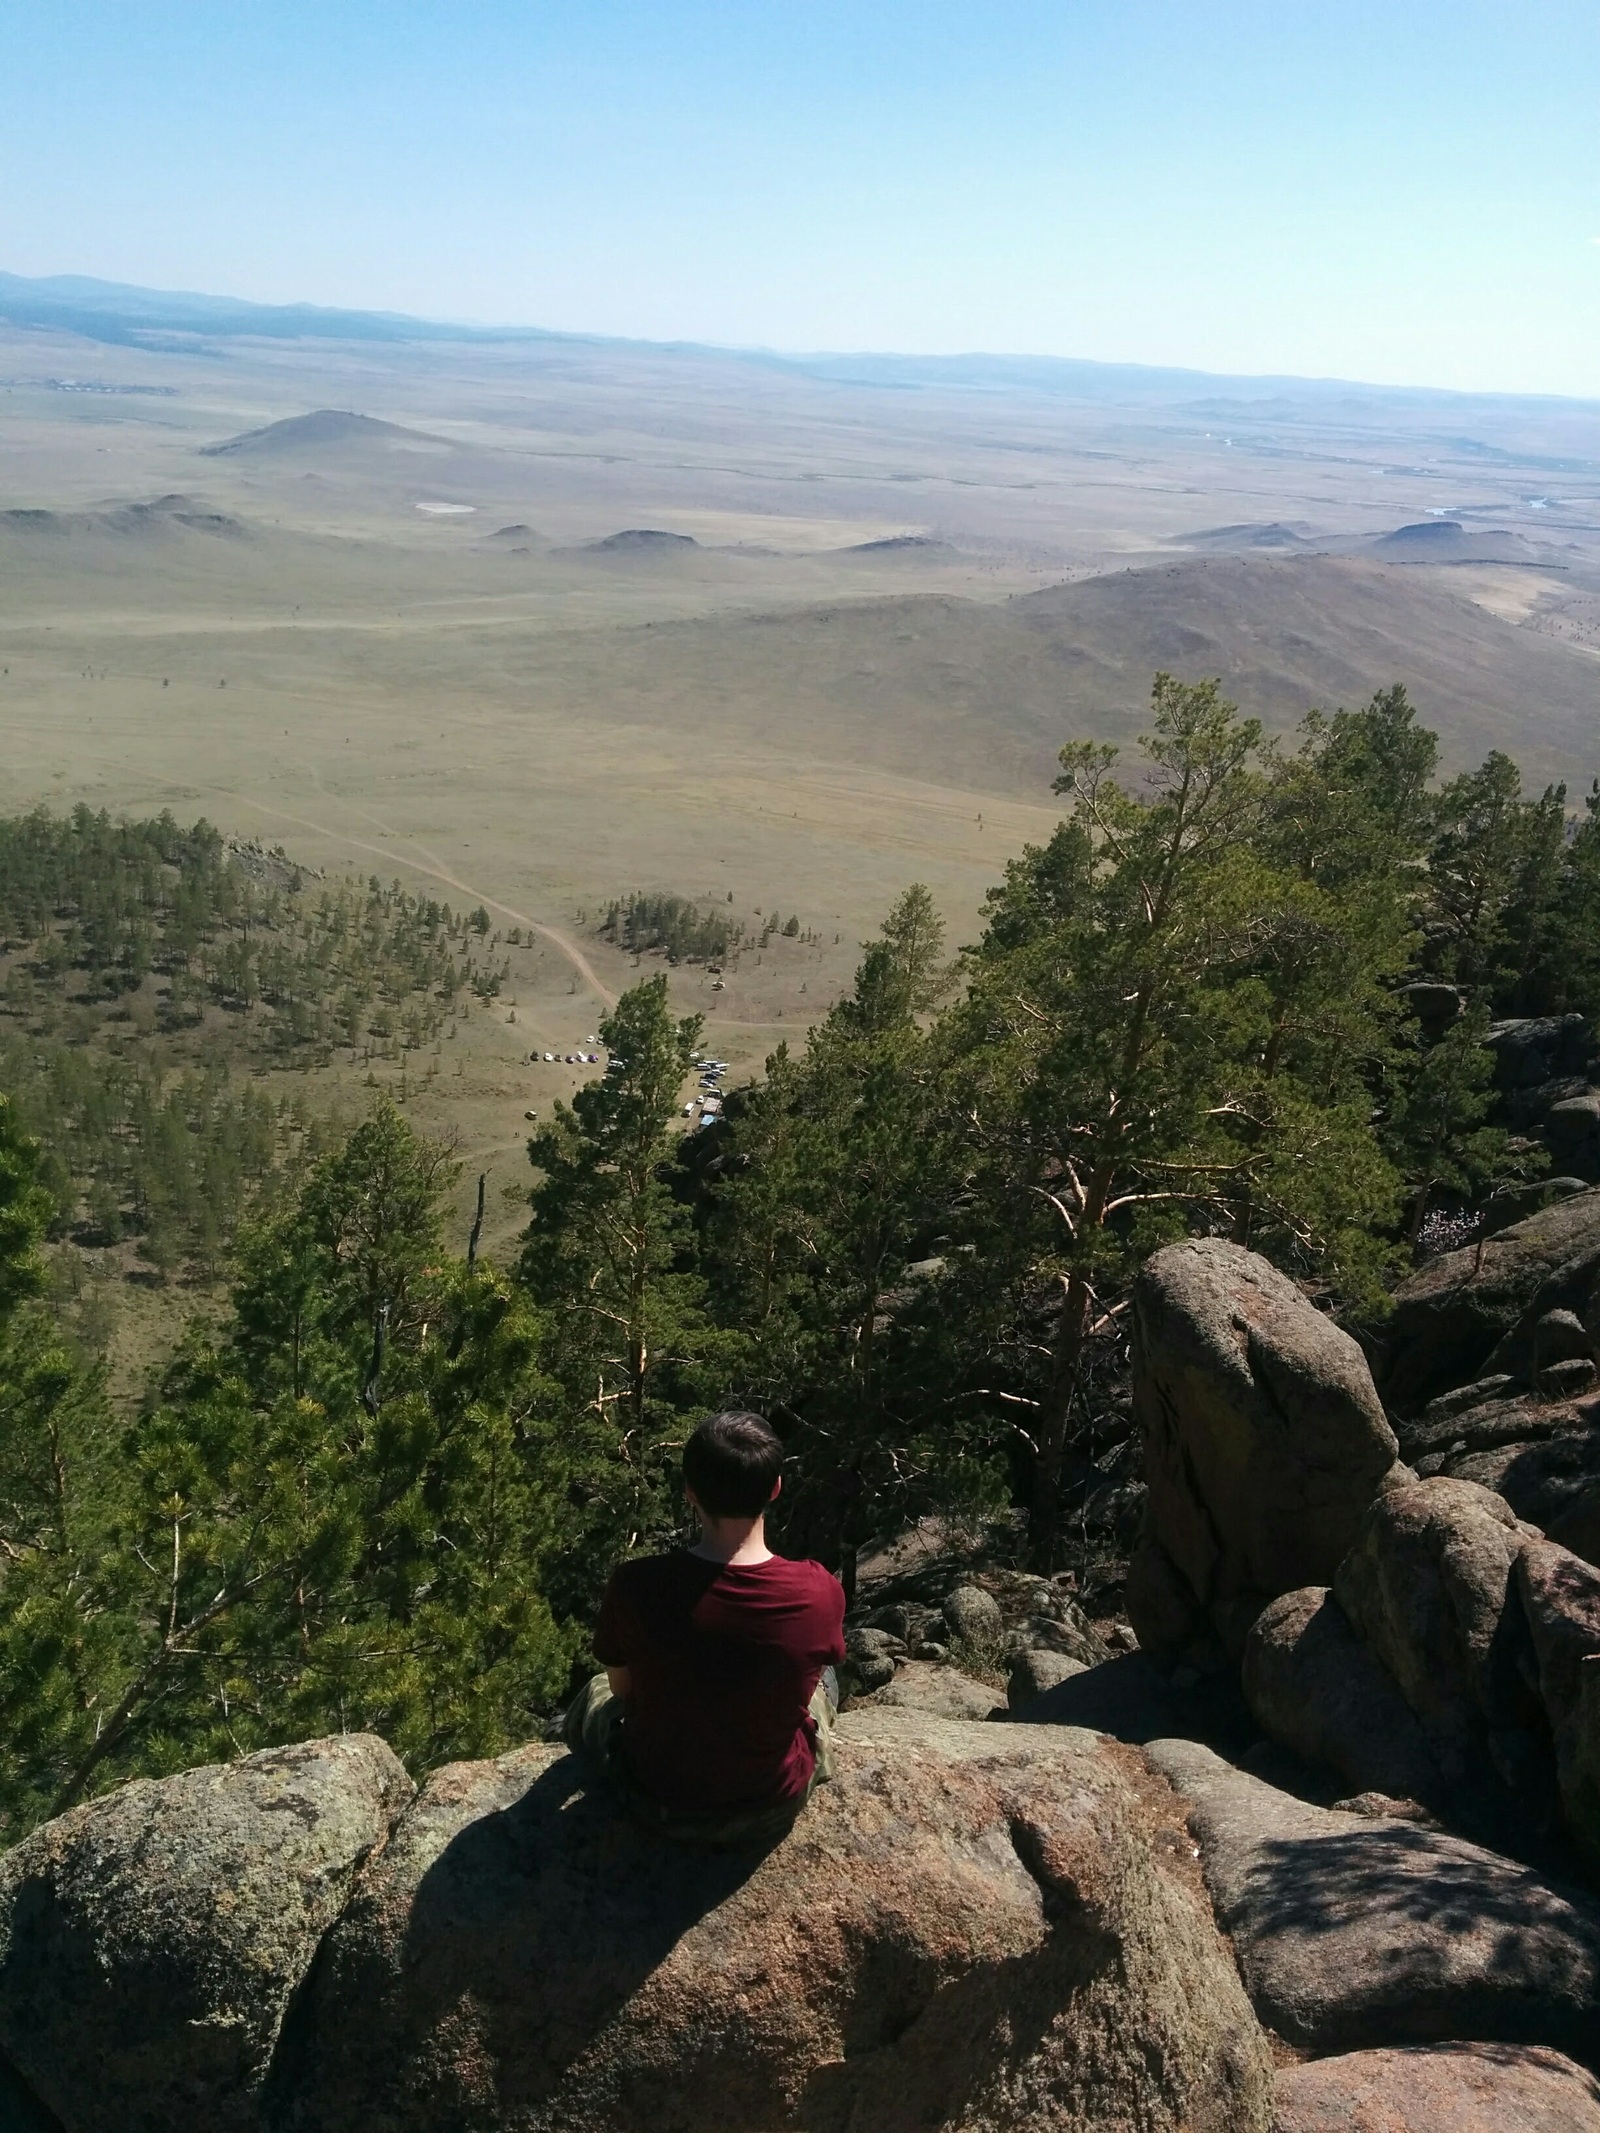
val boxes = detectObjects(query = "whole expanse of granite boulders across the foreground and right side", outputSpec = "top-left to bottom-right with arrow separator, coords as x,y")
0,1117 -> 1600,2133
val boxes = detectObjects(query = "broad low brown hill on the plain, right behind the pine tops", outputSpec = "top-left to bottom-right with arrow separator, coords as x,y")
518,555 -> 1600,798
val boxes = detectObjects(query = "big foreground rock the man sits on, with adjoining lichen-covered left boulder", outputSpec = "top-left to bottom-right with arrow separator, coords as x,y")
0,1706 -> 1271,2133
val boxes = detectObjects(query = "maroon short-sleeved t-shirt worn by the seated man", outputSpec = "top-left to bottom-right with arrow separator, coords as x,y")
595,1549 -> 845,1809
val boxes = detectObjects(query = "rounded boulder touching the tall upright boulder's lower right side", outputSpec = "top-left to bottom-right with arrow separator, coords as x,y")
1333,1476 -> 1536,1787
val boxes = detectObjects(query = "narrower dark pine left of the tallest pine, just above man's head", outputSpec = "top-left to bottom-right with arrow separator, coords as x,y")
710,883 -> 977,1589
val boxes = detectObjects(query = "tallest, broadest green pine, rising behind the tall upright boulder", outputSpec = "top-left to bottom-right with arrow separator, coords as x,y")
945,674 -> 1406,1566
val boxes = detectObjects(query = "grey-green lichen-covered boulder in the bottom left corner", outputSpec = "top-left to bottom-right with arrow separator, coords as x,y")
0,1734 -> 414,2133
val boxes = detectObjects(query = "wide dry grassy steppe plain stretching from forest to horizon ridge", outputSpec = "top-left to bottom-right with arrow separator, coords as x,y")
0,328 -> 1600,1271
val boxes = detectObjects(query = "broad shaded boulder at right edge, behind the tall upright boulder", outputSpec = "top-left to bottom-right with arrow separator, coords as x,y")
1374,1190 -> 1600,1414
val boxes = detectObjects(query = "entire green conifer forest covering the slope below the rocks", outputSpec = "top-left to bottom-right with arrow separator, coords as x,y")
0,674 -> 1600,1837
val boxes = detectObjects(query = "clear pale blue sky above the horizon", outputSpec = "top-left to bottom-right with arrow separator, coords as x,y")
0,0 -> 1600,395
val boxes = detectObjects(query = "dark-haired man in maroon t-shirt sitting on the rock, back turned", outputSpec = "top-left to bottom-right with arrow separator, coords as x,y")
563,1414 -> 845,1845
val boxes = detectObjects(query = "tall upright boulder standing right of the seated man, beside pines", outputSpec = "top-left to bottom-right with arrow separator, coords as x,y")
1129,1237 -> 1397,1659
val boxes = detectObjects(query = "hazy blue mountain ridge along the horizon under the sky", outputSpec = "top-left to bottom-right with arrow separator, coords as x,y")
0,269 -> 1600,410
